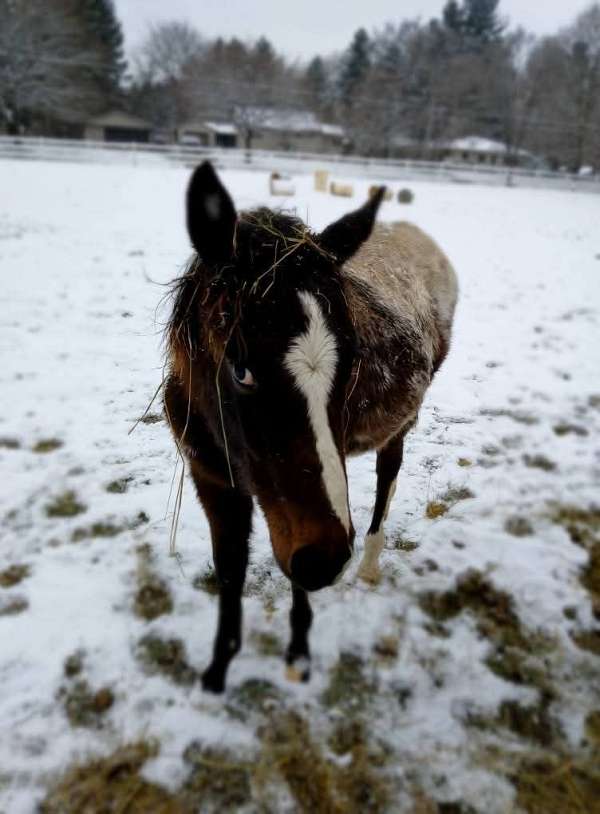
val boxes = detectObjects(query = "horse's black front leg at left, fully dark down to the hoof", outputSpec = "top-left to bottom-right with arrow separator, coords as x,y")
192,467 -> 252,693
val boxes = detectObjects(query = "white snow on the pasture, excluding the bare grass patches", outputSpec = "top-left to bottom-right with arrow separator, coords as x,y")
0,156 -> 600,814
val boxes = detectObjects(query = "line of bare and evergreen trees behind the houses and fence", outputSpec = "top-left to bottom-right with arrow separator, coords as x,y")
0,0 -> 600,170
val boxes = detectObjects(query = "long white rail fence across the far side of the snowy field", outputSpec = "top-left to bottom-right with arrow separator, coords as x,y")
0,136 -> 600,193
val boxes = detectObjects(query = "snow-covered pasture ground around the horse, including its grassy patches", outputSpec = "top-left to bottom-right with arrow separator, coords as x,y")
0,156 -> 600,814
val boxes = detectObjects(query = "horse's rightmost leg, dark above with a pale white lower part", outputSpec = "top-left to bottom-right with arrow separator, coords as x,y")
358,422 -> 414,583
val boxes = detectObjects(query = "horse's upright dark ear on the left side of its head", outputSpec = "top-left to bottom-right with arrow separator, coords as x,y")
186,161 -> 237,265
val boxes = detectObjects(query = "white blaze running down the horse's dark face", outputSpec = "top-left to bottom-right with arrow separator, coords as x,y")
284,291 -> 350,533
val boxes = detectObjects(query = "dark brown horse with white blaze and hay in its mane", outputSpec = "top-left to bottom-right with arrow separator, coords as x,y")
163,162 -> 458,693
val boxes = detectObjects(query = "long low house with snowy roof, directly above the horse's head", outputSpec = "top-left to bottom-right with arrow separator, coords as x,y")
233,106 -> 346,153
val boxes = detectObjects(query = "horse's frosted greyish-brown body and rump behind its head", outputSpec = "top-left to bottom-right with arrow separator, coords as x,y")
344,222 -> 458,451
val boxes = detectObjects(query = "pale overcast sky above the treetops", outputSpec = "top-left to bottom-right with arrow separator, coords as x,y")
115,0 -> 591,59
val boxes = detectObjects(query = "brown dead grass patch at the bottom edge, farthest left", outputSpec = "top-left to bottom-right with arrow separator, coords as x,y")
39,742 -> 184,814
